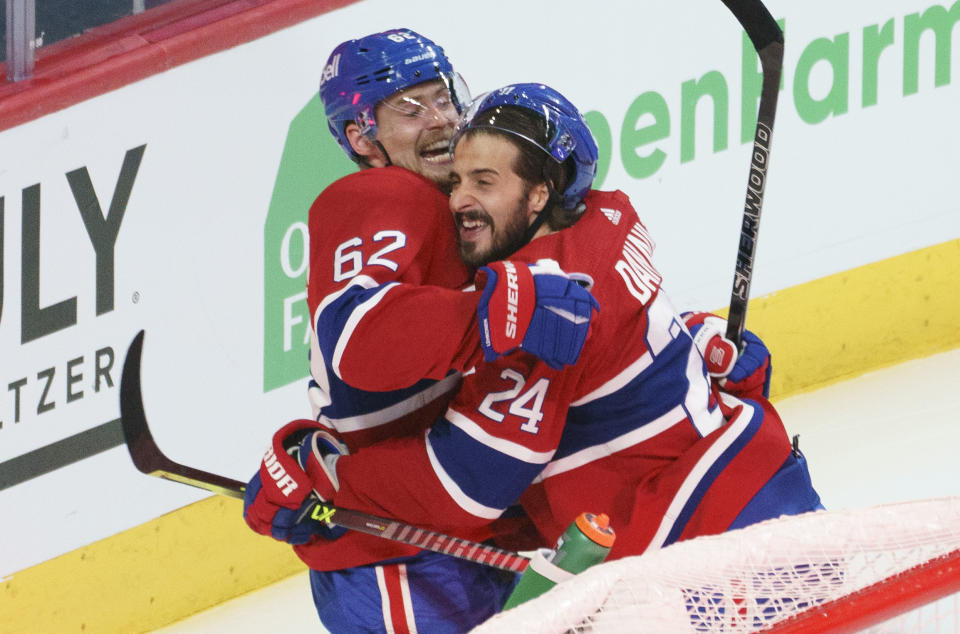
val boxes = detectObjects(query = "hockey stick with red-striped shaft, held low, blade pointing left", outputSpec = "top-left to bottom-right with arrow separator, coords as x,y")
120,330 -> 530,572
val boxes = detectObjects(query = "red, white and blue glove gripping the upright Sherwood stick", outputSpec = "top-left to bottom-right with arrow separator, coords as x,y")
683,312 -> 773,398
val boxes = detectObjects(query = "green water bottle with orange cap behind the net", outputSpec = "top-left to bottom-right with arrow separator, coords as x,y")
503,513 -> 616,610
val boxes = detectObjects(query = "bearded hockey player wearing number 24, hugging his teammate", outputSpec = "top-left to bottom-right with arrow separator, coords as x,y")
318,84 -> 821,558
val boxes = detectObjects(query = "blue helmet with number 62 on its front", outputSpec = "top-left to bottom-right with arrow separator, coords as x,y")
320,29 -> 470,160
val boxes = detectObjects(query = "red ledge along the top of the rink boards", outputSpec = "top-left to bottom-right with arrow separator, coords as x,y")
0,0 -> 360,130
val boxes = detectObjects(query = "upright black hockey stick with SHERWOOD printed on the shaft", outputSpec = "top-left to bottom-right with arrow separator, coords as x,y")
723,0 -> 783,350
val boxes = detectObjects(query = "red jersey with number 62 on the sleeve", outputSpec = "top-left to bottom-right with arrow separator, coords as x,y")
295,167 -> 520,570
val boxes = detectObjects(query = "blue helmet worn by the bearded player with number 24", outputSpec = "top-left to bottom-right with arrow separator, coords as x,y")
450,84 -> 599,209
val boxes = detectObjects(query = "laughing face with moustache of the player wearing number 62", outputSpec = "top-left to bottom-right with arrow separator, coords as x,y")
375,80 -> 457,186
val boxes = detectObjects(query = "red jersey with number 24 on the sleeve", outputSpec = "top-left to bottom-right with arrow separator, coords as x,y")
311,192 -> 790,566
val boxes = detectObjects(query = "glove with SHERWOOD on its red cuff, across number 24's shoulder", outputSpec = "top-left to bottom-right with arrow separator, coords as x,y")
476,260 -> 600,370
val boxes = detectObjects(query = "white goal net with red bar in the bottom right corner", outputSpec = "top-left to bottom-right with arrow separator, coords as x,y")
474,497 -> 960,634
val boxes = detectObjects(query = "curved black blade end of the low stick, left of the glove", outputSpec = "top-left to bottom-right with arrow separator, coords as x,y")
120,330 -> 244,498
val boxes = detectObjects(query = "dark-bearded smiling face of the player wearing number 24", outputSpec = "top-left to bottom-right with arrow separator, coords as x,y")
450,131 -> 546,266
